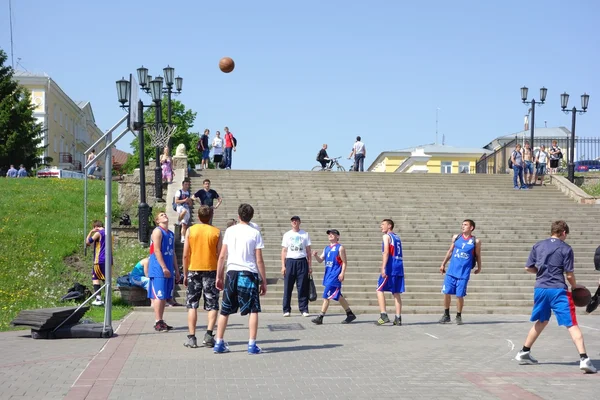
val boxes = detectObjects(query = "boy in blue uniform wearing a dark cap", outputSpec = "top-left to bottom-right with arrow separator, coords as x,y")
312,229 -> 356,325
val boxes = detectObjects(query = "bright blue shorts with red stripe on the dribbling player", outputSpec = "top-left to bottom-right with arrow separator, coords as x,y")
530,288 -> 577,328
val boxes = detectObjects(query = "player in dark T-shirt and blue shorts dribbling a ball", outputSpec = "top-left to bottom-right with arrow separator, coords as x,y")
515,221 -> 596,373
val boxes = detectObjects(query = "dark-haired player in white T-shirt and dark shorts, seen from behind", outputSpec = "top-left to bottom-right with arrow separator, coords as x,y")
213,204 -> 267,354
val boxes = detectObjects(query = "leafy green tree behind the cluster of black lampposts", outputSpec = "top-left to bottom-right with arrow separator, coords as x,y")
123,96 -> 201,173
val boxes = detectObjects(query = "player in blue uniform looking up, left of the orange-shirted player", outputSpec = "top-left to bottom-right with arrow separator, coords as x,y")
148,212 -> 179,332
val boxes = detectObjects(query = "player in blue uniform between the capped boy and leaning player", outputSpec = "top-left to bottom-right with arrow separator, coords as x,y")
375,219 -> 404,326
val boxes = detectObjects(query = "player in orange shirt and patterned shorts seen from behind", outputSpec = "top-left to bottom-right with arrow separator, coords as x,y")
183,206 -> 221,348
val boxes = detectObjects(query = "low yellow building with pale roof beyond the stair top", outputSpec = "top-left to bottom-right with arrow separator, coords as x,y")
368,144 -> 491,174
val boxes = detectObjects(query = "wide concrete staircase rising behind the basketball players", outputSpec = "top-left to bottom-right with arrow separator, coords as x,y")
144,170 -> 600,314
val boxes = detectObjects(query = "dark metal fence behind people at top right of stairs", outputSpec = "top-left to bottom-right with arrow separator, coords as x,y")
475,137 -> 600,174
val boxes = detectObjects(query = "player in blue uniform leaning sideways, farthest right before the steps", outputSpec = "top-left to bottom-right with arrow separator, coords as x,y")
439,219 -> 481,325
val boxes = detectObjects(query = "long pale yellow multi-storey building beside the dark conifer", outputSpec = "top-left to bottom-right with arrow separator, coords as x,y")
14,71 -> 102,171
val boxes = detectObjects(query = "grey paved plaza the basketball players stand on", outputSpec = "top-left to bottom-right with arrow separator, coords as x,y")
0,310 -> 600,400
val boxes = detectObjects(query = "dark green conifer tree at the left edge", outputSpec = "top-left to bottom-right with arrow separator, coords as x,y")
0,49 -> 52,170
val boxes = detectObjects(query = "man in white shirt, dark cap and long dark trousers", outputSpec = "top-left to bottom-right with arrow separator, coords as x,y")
281,215 -> 312,317
